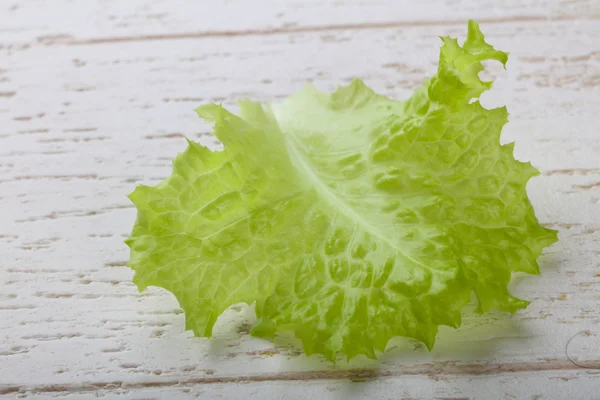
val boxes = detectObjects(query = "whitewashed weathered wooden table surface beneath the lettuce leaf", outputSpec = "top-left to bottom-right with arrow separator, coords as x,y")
0,0 -> 600,400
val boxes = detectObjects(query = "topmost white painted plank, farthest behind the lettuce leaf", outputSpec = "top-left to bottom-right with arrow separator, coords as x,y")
0,0 -> 600,44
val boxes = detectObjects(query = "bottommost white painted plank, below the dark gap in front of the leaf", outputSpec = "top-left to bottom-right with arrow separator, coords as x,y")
0,371 -> 600,400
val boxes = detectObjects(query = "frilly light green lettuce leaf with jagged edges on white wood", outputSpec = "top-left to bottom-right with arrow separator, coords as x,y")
127,21 -> 557,360
